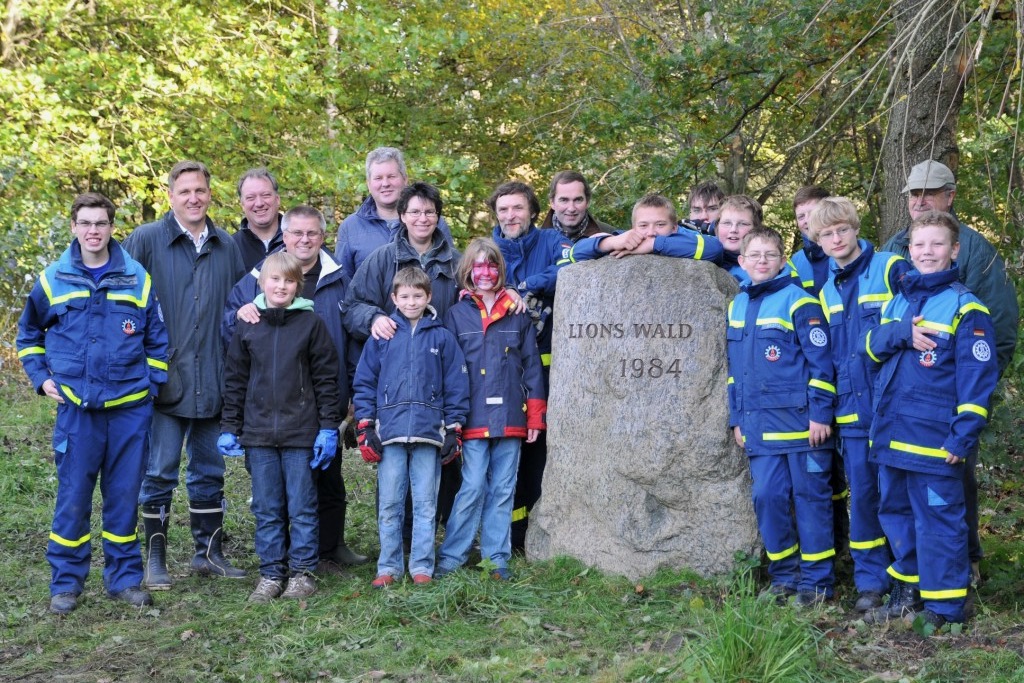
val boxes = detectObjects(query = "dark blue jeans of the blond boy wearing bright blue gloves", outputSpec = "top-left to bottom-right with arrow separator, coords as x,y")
246,446 -> 319,579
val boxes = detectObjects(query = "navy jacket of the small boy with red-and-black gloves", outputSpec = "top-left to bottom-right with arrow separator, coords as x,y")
353,307 -> 469,446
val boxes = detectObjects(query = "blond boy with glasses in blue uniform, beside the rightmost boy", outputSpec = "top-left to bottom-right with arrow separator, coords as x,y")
809,197 -> 910,612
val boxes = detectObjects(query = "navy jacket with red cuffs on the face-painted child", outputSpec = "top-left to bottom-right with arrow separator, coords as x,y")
444,291 -> 548,439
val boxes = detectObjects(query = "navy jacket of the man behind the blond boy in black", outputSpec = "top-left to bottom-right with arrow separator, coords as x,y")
220,249 -> 355,408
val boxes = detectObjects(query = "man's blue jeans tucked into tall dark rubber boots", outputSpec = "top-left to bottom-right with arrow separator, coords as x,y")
138,410 -> 224,509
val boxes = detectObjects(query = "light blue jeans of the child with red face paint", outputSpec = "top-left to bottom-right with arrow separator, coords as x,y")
437,438 -> 522,571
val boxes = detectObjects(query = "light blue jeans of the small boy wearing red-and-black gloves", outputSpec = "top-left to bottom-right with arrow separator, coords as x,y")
377,443 -> 441,578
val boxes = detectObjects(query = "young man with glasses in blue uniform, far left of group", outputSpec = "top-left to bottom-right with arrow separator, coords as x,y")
17,193 -> 167,614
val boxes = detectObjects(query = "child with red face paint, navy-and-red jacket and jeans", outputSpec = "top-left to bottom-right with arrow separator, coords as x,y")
437,239 -> 547,581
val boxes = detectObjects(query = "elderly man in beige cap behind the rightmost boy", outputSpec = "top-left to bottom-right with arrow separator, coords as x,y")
882,160 -> 1020,582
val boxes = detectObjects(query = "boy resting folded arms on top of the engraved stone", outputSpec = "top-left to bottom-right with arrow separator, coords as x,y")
569,195 -> 722,263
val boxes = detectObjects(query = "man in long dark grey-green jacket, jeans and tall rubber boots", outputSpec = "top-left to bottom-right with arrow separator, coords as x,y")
124,161 -> 245,591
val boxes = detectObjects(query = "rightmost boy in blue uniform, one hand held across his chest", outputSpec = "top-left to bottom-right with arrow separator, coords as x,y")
862,211 -> 999,628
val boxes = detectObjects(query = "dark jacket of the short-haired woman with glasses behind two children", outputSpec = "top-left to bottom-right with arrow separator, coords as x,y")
342,227 -> 460,341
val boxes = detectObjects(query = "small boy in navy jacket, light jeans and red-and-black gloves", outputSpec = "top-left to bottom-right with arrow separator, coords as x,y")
354,266 -> 469,588
